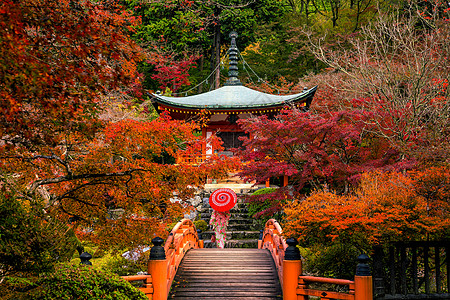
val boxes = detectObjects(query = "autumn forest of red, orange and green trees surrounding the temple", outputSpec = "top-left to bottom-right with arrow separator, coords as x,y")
0,0 -> 450,297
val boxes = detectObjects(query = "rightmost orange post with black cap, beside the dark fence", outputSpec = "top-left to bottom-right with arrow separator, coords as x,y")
355,254 -> 373,300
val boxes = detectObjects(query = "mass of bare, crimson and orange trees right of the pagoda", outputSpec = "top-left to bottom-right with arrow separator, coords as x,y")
240,1 -> 450,251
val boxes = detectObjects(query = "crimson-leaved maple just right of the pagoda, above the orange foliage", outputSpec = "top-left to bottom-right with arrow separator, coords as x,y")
239,109 -> 412,192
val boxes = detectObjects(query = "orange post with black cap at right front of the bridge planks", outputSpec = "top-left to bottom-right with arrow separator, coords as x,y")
283,238 -> 302,300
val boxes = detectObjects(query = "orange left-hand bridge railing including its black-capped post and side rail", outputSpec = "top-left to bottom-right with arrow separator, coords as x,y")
122,219 -> 203,300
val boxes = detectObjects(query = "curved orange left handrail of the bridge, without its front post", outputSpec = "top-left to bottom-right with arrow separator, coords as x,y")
164,219 -> 203,290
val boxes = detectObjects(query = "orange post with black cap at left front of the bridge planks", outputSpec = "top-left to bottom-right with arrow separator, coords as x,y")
148,237 -> 167,300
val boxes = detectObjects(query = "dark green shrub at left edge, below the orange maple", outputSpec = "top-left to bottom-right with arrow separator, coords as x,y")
0,193 -> 80,276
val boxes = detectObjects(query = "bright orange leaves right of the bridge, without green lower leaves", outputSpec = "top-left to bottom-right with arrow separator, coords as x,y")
283,168 -> 450,249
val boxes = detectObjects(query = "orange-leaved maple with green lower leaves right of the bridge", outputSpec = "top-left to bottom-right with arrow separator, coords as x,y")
283,166 -> 450,278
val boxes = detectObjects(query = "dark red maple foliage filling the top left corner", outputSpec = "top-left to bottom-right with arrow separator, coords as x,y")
0,0 -> 143,148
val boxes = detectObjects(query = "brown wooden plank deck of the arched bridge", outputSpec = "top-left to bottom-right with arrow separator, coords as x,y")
168,248 -> 282,300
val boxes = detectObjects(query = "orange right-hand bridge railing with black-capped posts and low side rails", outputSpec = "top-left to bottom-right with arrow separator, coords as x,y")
258,219 -> 373,300
